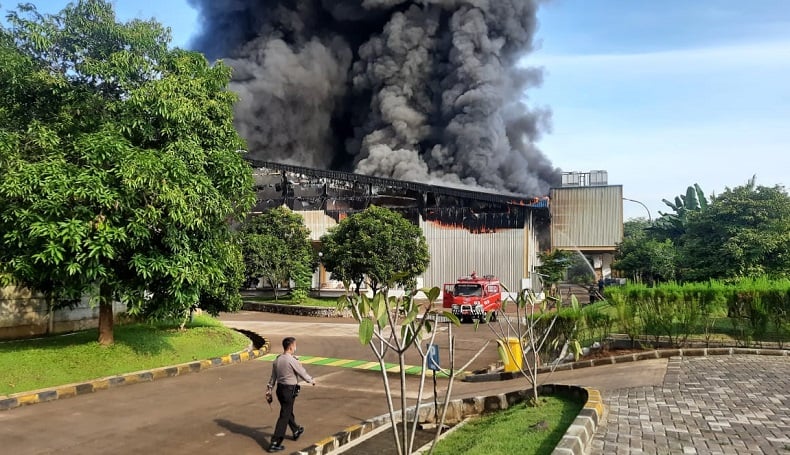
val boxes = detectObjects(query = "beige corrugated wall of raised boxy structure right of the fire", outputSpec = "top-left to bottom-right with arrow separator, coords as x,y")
551,185 -> 623,250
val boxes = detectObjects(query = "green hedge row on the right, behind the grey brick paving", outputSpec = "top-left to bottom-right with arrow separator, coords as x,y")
537,278 -> 790,357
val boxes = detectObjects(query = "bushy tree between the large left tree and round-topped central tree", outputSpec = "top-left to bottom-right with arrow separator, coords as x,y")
242,207 -> 316,300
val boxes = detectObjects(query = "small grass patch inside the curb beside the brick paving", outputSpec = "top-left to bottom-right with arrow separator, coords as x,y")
433,396 -> 584,455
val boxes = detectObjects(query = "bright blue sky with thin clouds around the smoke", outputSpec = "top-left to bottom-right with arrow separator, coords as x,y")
7,0 -> 790,219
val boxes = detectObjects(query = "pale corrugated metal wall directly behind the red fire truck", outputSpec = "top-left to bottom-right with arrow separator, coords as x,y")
420,220 -> 535,290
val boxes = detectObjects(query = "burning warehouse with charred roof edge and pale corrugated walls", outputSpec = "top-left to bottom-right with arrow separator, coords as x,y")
251,161 -> 549,290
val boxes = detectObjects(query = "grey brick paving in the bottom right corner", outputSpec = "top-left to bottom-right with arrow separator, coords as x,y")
590,355 -> 790,455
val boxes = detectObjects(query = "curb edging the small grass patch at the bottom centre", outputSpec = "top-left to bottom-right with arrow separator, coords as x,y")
295,384 -> 604,455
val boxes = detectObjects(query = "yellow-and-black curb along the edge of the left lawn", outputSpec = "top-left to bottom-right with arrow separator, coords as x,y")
0,330 -> 271,411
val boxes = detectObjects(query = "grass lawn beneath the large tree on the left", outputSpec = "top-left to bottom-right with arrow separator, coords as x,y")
0,316 -> 250,395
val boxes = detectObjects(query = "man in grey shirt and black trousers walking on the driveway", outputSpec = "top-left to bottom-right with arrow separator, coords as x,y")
266,337 -> 315,452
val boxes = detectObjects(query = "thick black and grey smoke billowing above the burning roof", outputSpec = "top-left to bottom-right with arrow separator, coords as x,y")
190,0 -> 559,194
